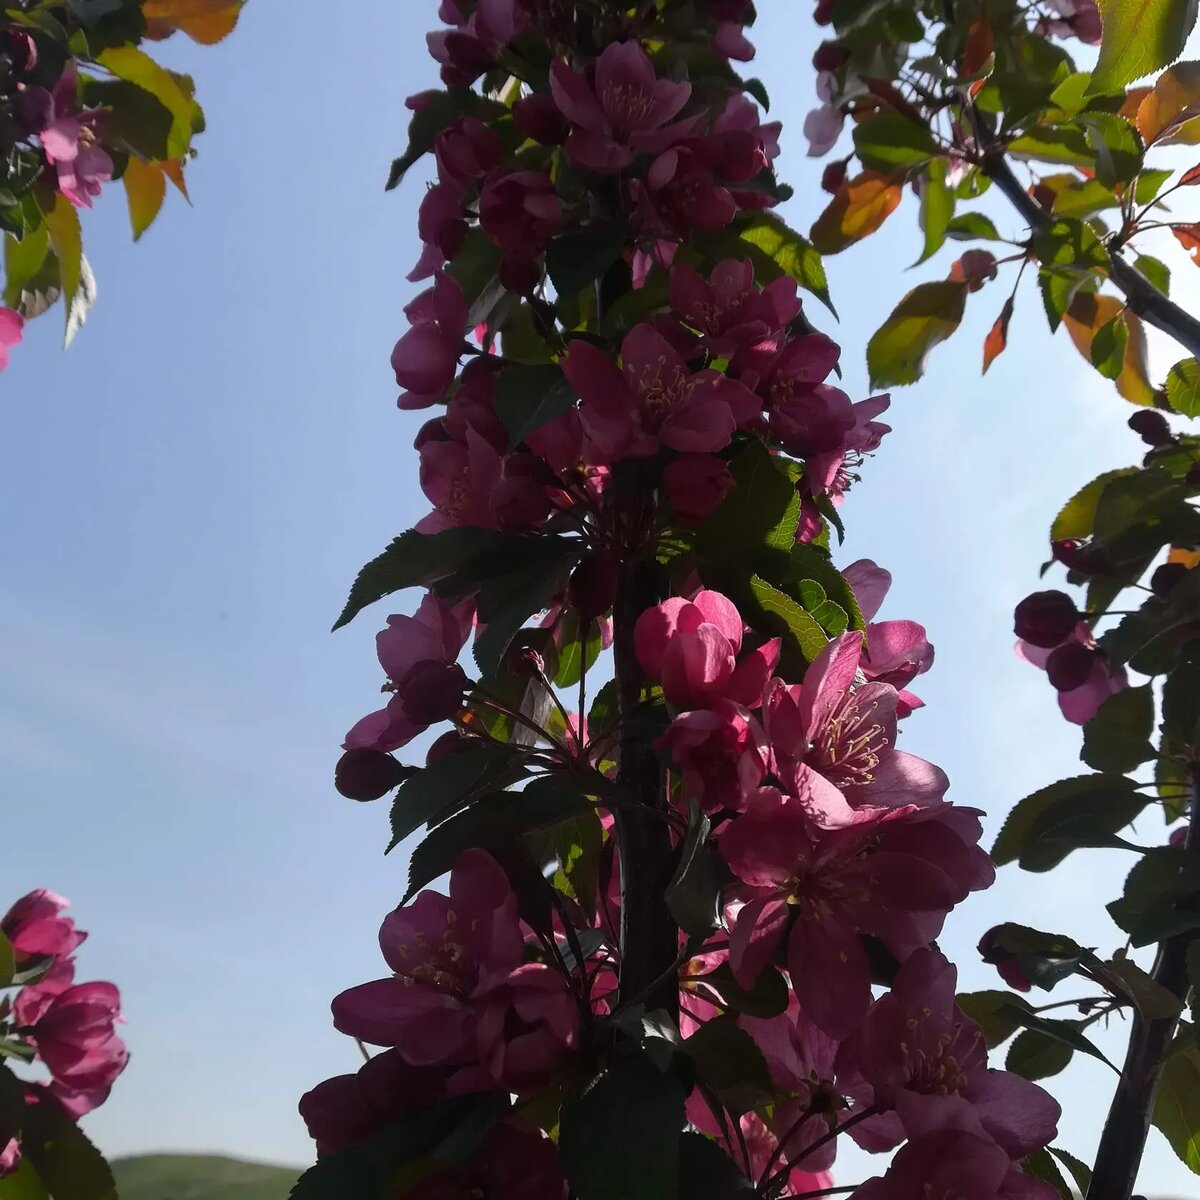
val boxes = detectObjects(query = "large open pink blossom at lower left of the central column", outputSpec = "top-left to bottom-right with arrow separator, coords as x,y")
334,850 -> 523,1067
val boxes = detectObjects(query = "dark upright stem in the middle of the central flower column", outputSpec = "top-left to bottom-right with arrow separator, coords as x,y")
613,463 -> 679,1018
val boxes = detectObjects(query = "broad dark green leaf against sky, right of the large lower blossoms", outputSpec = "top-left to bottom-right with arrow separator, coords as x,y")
991,775 -> 1146,871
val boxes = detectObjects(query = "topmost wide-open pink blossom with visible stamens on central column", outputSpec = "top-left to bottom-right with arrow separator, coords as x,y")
550,42 -> 698,172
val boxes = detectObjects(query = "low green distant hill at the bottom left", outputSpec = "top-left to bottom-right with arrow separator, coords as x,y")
113,1154 -> 300,1200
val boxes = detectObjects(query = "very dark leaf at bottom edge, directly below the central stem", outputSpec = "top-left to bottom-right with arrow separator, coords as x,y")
558,1055 -> 684,1200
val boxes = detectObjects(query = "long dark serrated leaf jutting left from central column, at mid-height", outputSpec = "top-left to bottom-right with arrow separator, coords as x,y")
334,527 -> 578,630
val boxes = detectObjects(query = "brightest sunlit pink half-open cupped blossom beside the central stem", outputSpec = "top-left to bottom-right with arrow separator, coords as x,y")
634,592 -> 780,709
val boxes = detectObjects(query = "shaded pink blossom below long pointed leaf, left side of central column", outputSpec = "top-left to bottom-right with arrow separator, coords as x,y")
343,593 -> 472,754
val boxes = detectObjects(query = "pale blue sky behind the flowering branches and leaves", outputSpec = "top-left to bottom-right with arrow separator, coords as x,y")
0,0 -> 1200,1195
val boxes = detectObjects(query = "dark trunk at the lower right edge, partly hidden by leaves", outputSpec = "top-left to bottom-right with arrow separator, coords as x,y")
1087,768 -> 1200,1200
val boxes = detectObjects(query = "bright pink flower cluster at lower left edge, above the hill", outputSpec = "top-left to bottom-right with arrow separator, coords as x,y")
0,888 -> 130,1177
